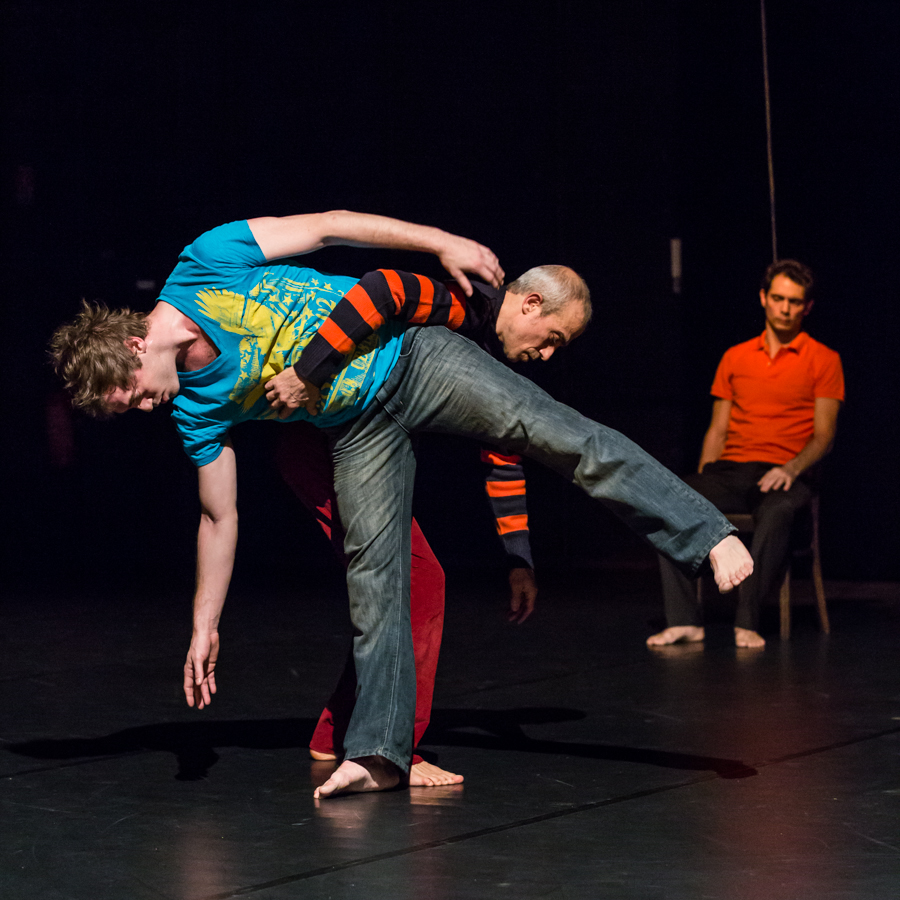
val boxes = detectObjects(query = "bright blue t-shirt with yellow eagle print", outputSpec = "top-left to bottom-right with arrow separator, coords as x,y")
159,221 -> 402,466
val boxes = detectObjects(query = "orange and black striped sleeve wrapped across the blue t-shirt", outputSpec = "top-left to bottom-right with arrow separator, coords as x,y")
294,269 -> 469,386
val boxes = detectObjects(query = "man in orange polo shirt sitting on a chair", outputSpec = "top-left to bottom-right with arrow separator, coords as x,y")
647,259 -> 844,647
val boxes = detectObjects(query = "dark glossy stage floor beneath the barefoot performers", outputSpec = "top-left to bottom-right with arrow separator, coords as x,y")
0,571 -> 900,900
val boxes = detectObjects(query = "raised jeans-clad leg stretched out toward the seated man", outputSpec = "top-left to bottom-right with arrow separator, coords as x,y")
384,328 -> 749,580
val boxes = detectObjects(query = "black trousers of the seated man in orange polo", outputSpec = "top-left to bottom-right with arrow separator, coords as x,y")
660,460 -> 812,631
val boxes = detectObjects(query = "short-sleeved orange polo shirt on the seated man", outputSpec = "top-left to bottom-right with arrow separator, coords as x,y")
710,331 -> 844,465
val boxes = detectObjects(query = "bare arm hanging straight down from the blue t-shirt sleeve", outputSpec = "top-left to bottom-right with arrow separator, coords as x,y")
184,442 -> 237,709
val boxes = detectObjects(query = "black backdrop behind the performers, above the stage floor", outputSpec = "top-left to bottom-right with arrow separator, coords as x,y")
0,0 -> 900,593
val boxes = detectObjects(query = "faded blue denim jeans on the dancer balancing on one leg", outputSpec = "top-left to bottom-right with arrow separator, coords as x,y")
333,327 -> 734,769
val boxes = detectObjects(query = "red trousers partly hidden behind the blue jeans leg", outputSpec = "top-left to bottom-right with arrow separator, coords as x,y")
275,422 -> 444,764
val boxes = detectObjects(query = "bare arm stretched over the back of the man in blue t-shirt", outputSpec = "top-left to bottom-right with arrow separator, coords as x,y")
248,210 -> 504,297
